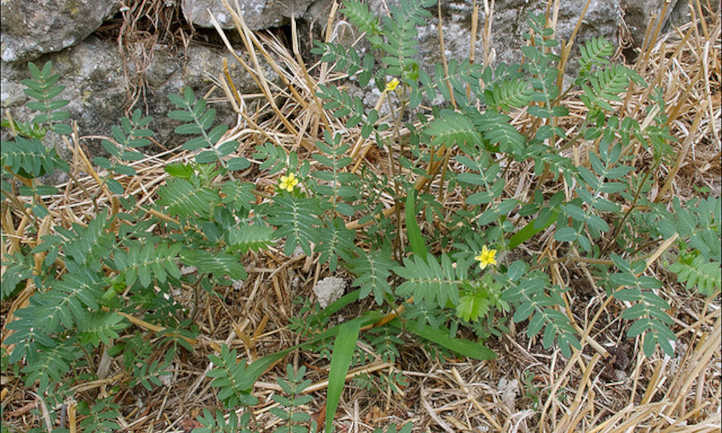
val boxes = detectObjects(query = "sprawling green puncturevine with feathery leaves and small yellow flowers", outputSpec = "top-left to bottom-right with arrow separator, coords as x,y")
1,0 -> 721,433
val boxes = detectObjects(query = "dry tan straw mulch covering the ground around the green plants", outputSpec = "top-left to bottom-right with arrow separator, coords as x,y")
1,1 -> 722,433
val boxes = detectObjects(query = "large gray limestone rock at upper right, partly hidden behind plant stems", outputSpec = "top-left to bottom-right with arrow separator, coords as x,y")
334,0 -> 689,72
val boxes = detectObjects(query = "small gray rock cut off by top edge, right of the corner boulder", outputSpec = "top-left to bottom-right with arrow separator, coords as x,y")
181,0 -> 313,30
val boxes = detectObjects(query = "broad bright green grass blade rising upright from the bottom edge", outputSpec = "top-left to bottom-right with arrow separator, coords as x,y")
326,320 -> 361,433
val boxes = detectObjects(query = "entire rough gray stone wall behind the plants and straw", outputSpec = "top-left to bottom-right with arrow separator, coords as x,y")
0,0 -> 687,160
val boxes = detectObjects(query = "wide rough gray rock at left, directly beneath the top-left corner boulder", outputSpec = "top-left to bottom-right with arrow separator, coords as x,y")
1,36 -> 277,155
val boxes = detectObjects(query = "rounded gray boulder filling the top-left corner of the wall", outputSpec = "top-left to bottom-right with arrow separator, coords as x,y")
0,0 -> 120,62
